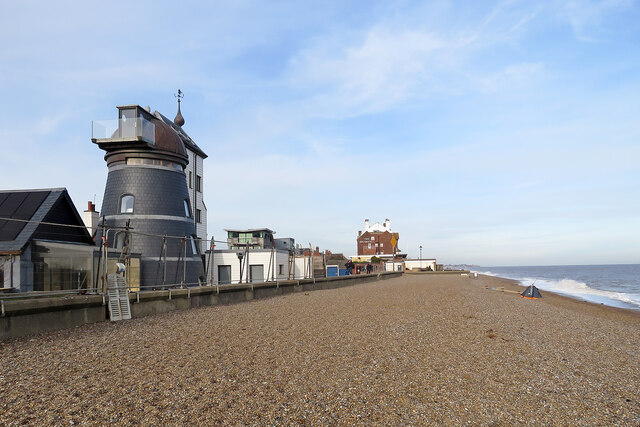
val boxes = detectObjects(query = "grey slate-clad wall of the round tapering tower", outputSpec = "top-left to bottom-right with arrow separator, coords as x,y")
101,165 -> 204,287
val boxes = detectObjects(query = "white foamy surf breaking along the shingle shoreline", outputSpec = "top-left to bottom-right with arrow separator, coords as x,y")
470,271 -> 640,310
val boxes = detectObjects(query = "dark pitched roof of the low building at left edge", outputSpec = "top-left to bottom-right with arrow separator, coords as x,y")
0,188 -> 93,253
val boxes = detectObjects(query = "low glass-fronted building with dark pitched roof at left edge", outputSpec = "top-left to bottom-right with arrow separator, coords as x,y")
0,188 -> 95,292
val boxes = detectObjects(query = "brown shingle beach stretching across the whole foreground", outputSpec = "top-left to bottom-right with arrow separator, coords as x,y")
0,274 -> 640,426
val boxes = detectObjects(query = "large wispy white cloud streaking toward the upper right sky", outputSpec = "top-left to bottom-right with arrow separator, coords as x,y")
288,2 -> 544,118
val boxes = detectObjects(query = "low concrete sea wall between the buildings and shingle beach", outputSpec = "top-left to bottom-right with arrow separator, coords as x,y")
0,272 -> 402,340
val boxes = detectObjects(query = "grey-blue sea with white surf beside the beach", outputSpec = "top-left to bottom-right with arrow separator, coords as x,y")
470,264 -> 640,310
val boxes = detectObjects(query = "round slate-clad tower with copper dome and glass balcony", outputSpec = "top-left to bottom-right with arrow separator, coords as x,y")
91,105 -> 205,288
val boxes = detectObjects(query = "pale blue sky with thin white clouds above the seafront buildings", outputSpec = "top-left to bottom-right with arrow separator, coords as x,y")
0,0 -> 640,266
